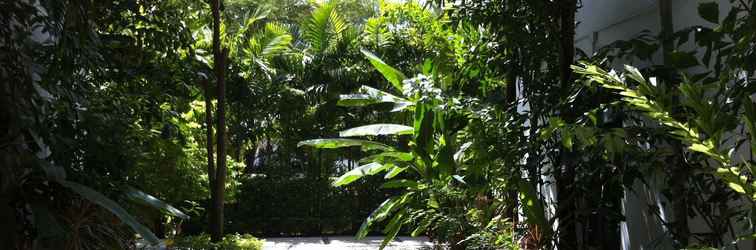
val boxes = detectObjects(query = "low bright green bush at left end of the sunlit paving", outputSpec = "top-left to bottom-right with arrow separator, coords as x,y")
168,234 -> 264,250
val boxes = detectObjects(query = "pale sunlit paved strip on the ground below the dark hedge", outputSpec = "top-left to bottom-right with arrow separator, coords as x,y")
263,236 -> 433,250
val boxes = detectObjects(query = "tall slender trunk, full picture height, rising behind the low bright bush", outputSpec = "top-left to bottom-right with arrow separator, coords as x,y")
209,0 -> 226,242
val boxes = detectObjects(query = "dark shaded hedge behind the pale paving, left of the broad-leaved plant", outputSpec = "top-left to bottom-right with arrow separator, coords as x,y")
226,172 -> 387,236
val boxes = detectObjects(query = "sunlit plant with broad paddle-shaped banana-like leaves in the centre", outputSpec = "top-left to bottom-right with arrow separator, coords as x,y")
298,50 -> 469,249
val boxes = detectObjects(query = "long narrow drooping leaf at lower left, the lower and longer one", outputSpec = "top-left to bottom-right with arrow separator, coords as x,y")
58,180 -> 160,245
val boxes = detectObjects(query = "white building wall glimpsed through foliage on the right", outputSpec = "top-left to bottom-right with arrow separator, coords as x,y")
575,0 -> 754,250
